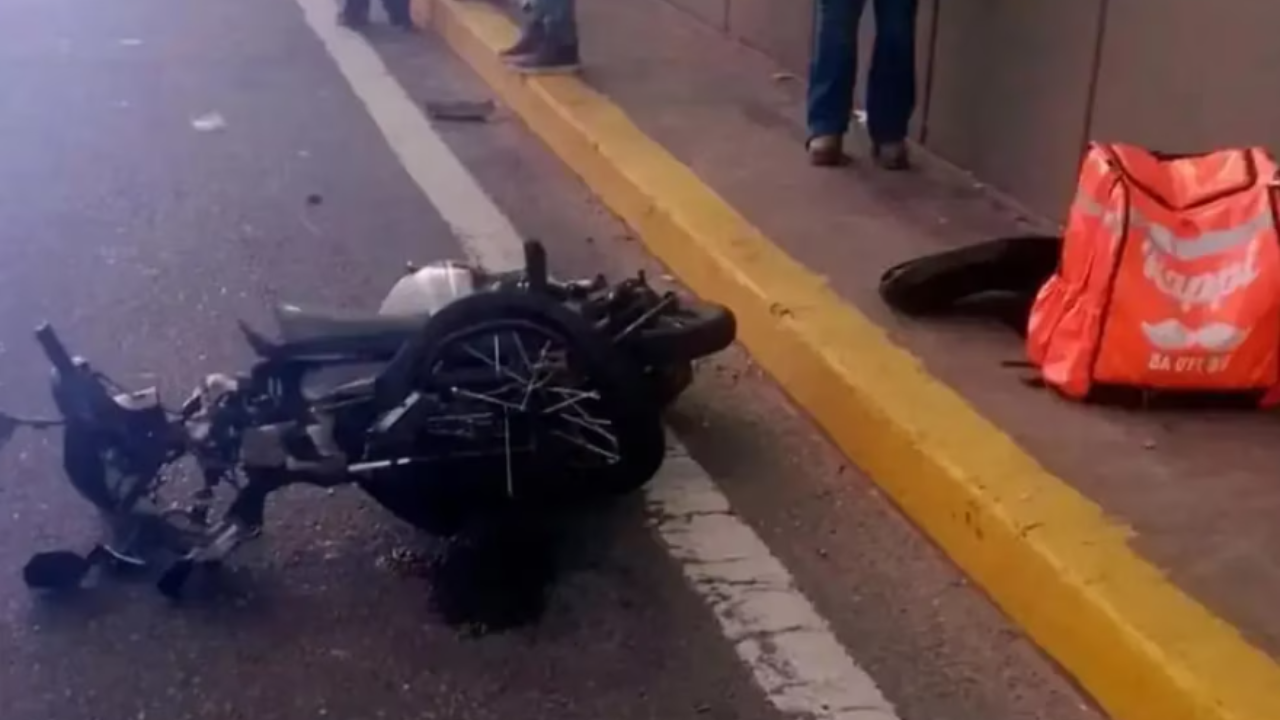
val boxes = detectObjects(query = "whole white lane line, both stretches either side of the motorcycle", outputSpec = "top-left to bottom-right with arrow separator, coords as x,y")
294,7 -> 897,720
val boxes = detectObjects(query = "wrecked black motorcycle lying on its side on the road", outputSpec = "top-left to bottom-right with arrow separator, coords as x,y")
0,242 -> 736,598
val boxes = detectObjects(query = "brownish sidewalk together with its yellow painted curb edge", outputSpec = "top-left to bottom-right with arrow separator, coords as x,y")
417,0 -> 1280,720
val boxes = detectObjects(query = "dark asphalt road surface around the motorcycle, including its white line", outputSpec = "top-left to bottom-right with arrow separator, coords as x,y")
0,0 -> 1098,720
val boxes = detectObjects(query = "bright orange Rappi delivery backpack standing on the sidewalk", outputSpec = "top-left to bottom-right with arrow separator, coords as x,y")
1027,143 -> 1280,406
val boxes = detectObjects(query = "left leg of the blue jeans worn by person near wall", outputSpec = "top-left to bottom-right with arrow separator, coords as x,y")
808,0 -> 865,137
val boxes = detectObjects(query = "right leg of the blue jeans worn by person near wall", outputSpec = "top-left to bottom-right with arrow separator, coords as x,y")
867,0 -> 916,145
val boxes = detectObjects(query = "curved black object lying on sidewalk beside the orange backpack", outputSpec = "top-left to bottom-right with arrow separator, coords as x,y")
879,236 -> 1062,332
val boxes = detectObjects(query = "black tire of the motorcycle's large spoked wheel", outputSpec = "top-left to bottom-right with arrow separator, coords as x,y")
360,291 -> 666,534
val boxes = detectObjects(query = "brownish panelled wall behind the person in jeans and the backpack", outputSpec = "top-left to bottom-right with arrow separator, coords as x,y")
667,0 -> 1280,219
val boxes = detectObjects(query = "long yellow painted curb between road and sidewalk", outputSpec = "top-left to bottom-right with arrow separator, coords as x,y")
415,0 -> 1280,720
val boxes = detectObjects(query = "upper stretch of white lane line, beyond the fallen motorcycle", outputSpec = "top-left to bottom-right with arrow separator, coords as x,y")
296,0 -> 524,270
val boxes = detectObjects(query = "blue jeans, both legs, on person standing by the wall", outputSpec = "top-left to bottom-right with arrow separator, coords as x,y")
808,0 -> 916,143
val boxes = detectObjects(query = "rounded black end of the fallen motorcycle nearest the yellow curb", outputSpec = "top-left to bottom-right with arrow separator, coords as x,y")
622,299 -> 737,365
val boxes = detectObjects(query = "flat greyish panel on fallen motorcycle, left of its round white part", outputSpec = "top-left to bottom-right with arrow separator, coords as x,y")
241,305 -> 430,360
